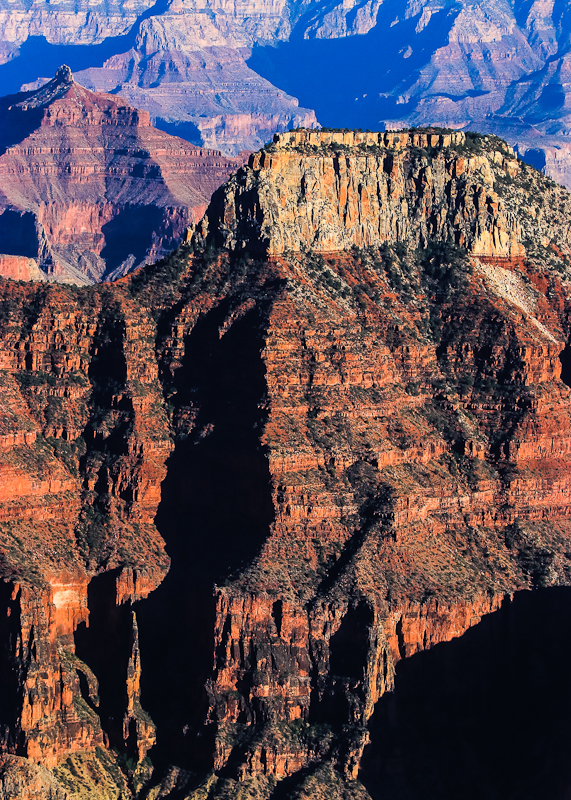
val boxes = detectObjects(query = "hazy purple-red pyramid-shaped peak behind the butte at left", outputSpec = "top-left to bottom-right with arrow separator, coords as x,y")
0,67 -> 241,284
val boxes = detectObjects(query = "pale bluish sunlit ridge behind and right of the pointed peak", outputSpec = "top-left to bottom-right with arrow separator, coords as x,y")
72,9 -> 317,155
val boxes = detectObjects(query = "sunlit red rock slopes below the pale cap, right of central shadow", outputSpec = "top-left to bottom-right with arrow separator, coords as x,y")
183,245 -> 571,780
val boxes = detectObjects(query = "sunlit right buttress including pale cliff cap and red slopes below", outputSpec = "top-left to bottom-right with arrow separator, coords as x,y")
181,132 -> 571,791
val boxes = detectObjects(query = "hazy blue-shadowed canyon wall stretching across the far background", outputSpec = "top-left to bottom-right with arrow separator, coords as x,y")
0,0 -> 571,185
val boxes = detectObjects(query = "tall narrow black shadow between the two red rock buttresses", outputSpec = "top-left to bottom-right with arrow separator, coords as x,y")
137,303 -> 273,772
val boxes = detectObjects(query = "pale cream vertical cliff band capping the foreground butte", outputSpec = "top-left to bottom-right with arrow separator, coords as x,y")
201,131 -> 524,258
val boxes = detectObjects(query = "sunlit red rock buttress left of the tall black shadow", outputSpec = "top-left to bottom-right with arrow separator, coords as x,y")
0,283 -> 170,767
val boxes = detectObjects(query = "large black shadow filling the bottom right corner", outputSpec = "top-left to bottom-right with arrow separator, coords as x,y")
359,588 -> 571,800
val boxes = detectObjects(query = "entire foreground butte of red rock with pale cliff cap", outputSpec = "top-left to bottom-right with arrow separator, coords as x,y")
0,131 -> 571,798
